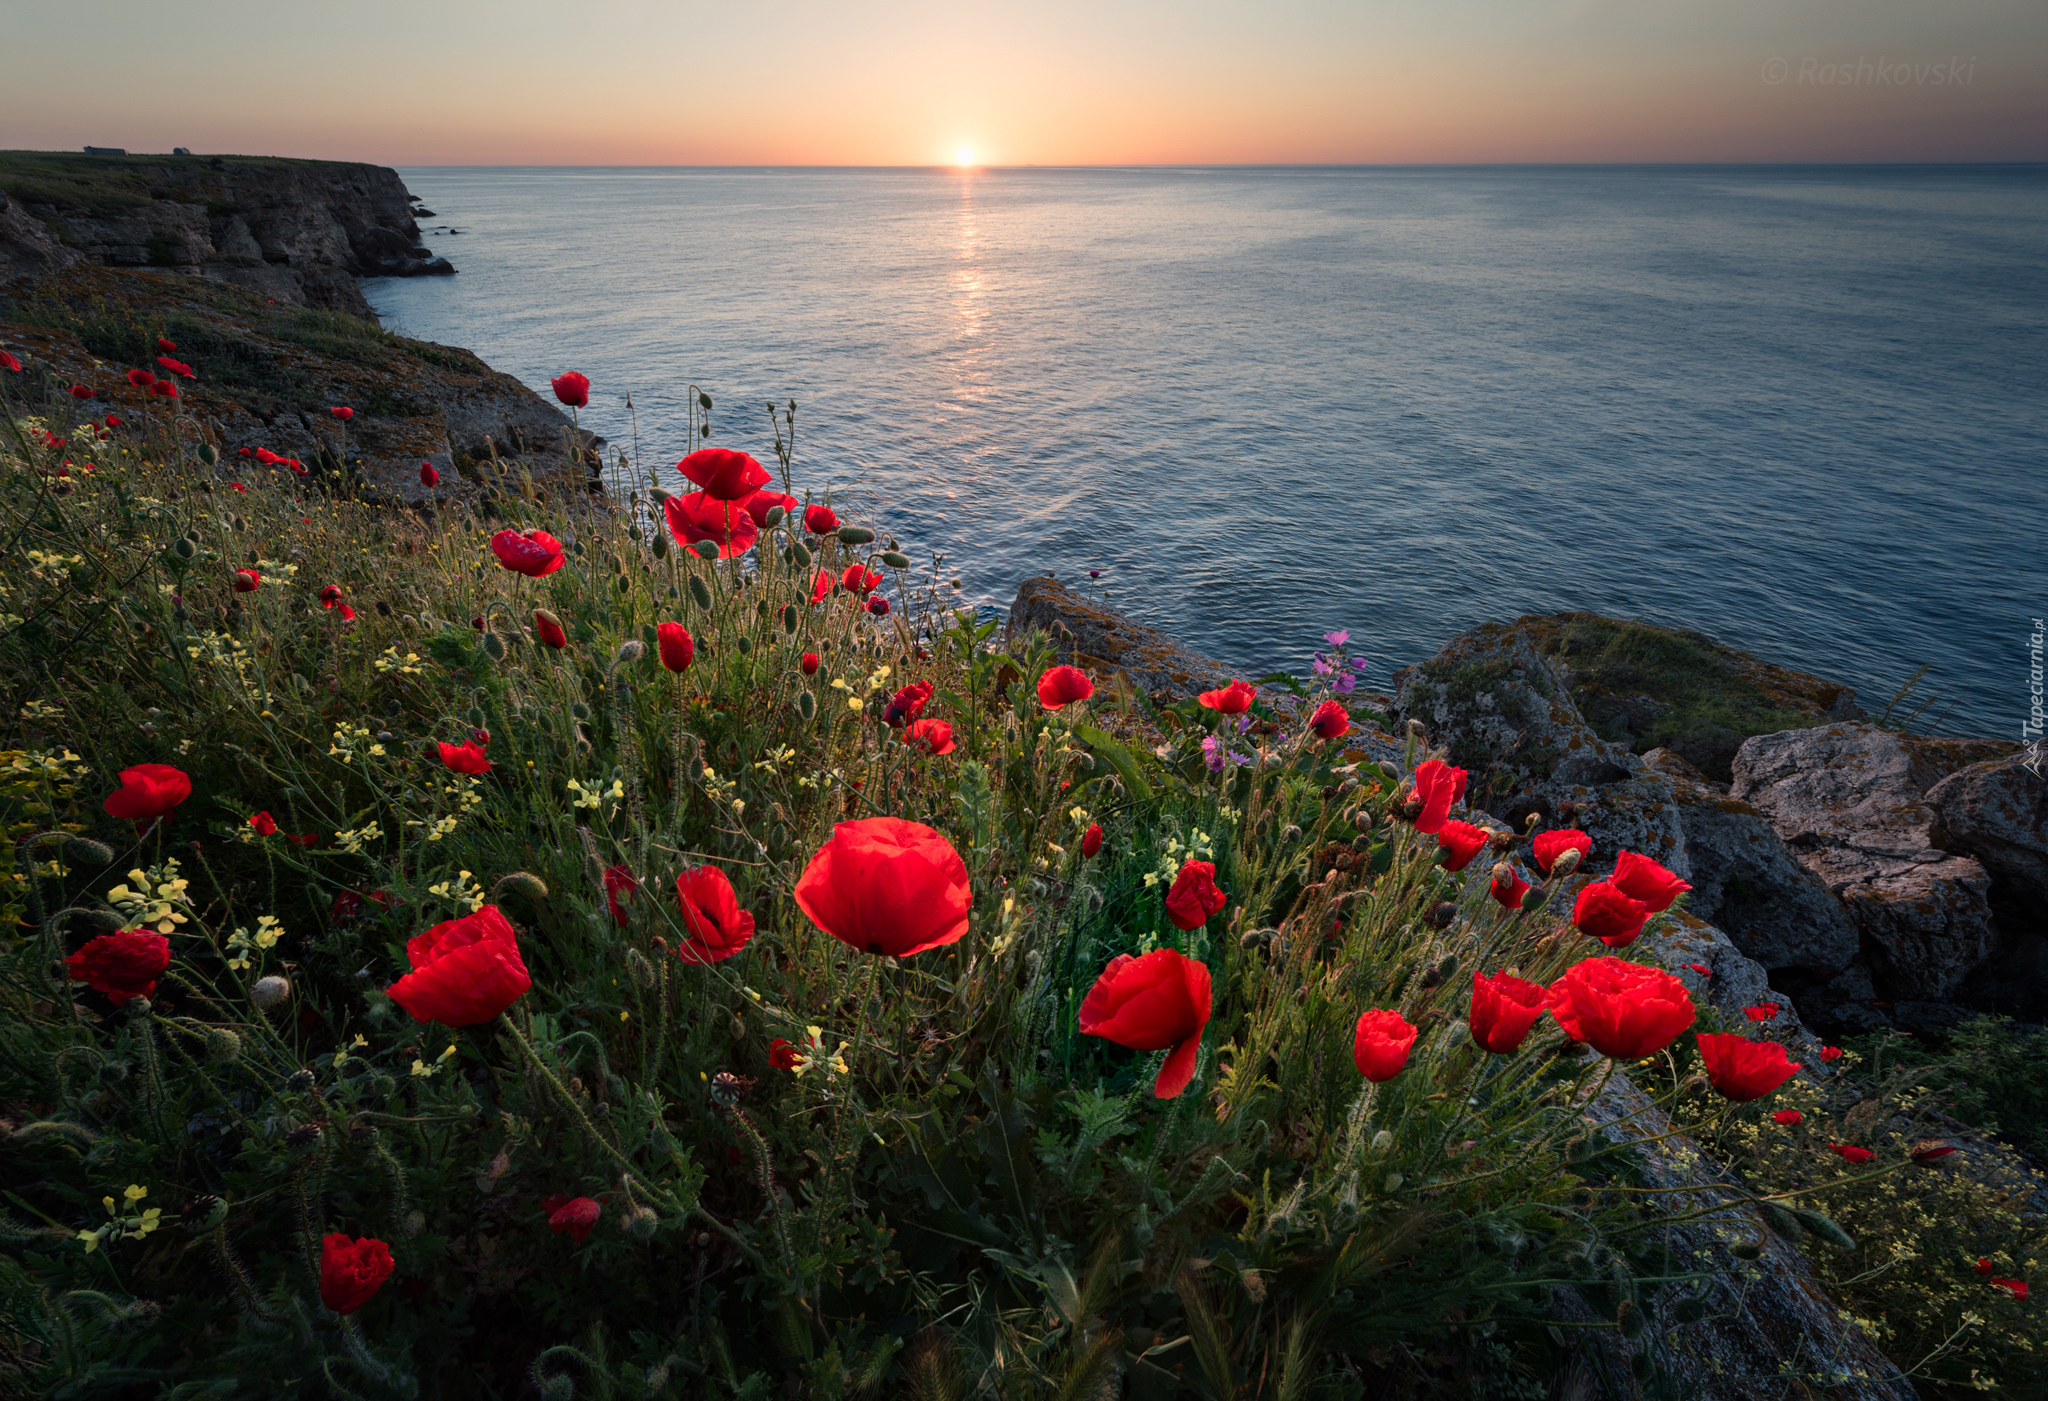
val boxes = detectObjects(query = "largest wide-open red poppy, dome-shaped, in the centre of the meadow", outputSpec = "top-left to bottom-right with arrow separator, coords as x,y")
797,817 -> 973,959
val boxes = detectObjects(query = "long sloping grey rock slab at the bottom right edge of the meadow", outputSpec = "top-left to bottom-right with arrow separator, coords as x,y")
1583,1073 -> 1915,1401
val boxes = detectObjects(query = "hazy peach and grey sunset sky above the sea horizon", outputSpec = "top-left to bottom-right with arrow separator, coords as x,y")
0,0 -> 2048,166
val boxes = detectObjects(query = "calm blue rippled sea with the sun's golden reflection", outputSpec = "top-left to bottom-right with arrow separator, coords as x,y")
367,166 -> 2048,735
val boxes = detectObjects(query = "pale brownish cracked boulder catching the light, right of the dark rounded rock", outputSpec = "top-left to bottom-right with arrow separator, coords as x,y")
1731,721 -> 1997,1004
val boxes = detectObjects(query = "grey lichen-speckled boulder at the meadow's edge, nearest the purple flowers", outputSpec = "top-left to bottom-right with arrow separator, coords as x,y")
1393,623 -> 1686,875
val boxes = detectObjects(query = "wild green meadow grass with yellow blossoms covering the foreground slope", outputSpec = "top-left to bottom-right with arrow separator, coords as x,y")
0,364 -> 2017,1401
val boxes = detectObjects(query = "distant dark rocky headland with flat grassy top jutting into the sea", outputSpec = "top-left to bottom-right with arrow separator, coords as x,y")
0,152 -> 455,315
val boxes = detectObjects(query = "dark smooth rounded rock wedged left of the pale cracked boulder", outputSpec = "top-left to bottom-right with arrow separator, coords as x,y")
1642,750 -> 1860,983
